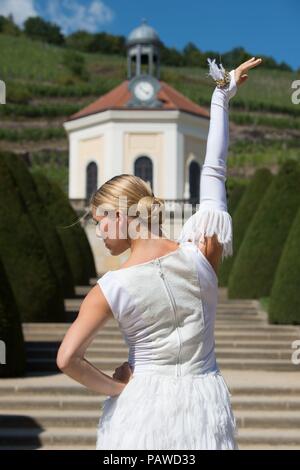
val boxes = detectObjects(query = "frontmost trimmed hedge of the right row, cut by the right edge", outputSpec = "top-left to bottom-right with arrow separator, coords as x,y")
268,208 -> 300,324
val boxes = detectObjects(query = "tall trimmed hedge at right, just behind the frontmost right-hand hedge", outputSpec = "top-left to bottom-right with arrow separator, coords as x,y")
228,160 -> 300,298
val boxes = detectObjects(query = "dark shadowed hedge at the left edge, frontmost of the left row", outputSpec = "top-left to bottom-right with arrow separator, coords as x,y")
0,255 -> 26,378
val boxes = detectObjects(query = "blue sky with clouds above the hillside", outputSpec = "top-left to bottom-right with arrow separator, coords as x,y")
0,0 -> 300,69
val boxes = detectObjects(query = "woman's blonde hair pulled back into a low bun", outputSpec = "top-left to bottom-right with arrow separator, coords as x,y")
89,173 -> 165,234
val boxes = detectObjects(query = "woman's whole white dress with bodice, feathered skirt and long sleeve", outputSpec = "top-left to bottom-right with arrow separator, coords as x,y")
96,60 -> 238,450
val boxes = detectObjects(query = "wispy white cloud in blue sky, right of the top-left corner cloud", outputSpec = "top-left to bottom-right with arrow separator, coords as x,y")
45,0 -> 114,34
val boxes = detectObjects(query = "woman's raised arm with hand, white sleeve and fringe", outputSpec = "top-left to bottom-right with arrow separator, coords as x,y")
179,57 -> 261,264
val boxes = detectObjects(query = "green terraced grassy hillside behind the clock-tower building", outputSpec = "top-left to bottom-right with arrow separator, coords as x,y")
0,34 -> 300,190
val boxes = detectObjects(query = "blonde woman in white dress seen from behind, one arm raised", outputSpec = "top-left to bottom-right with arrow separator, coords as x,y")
57,57 -> 261,450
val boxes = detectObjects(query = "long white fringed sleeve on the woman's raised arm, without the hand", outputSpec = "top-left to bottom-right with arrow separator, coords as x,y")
179,64 -> 237,259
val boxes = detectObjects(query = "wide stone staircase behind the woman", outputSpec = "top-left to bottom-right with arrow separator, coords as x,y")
0,287 -> 300,449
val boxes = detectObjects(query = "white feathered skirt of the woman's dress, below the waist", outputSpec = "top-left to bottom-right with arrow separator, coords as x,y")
96,371 -> 238,450
